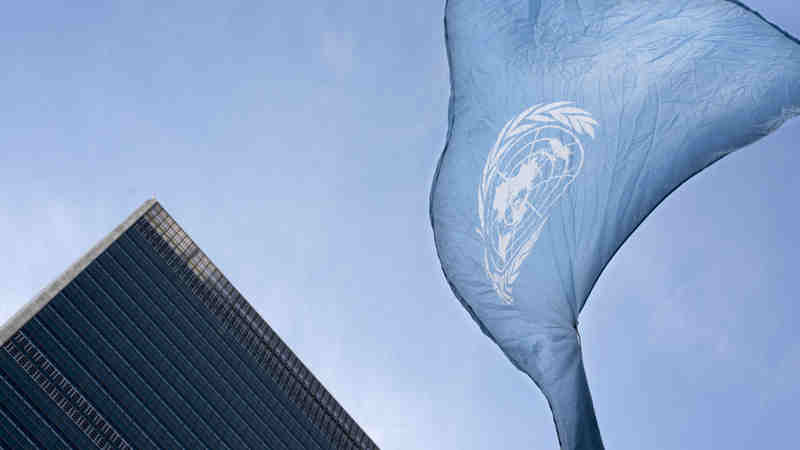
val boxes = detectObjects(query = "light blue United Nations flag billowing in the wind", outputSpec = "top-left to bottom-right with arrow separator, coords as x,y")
430,0 -> 800,449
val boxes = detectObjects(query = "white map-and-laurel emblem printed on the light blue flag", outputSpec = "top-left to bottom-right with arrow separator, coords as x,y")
477,102 -> 597,303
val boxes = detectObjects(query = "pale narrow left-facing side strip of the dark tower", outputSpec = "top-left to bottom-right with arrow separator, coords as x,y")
0,198 -> 157,346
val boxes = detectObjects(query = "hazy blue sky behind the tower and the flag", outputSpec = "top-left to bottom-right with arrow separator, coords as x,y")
0,0 -> 800,449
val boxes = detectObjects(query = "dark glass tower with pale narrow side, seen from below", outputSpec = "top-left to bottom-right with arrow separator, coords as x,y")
0,200 -> 377,450
